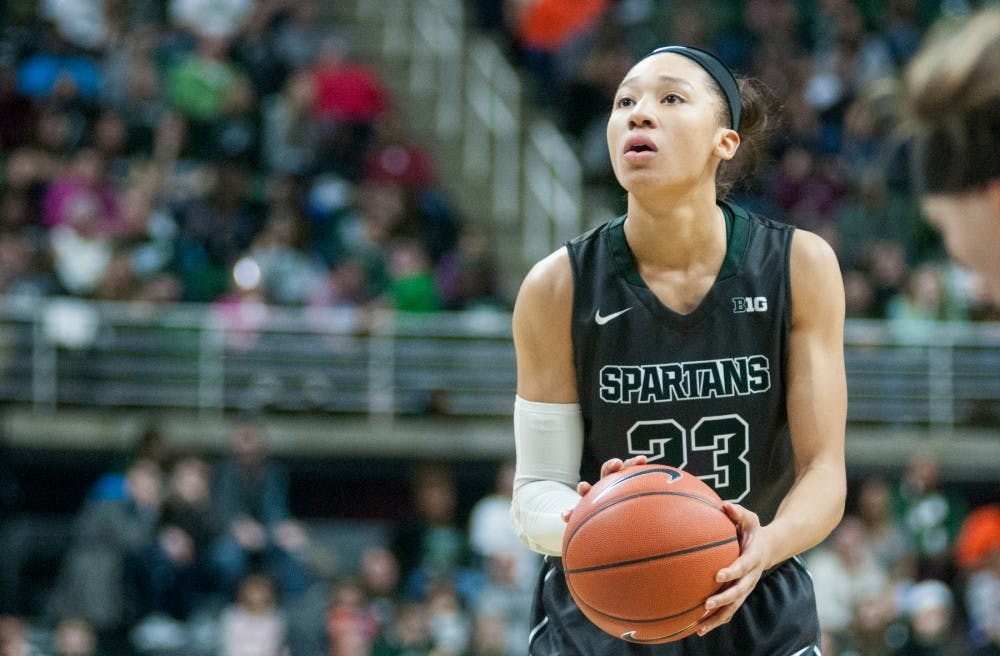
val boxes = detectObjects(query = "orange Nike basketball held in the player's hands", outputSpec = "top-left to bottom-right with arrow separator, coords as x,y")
562,465 -> 740,644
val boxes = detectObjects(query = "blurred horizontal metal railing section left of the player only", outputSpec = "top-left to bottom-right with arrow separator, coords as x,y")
0,299 -> 515,418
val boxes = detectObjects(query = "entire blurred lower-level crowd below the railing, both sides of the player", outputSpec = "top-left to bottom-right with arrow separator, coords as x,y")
0,419 -> 1000,656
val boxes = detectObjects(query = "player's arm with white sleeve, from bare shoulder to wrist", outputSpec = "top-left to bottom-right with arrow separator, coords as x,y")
511,249 -> 583,555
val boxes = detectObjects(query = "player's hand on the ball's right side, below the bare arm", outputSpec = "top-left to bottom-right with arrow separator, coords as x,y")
698,503 -> 770,635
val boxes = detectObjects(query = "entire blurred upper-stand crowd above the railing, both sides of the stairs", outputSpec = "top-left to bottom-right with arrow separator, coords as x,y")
0,0 -> 1000,322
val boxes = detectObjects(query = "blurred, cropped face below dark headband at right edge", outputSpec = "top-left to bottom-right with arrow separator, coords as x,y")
923,188 -> 1000,302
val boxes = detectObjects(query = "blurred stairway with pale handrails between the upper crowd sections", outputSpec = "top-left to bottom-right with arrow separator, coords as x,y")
358,0 -> 583,269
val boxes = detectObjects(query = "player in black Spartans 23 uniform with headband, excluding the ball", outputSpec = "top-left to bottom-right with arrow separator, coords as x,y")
512,46 -> 846,656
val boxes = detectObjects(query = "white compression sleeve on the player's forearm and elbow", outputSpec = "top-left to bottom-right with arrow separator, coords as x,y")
511,397 -> 583,556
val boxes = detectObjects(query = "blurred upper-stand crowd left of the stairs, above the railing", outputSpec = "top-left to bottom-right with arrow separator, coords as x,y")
0,0 -> 505,312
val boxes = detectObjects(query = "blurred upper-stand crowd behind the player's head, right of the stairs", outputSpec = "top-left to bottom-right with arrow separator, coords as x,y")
468,0 -> 1000,322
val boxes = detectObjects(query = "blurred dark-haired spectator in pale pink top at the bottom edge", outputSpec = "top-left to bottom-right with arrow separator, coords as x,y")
219,574 -> 287,656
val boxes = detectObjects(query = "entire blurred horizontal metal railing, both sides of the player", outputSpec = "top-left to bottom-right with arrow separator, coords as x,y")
0,299 -> 1000,429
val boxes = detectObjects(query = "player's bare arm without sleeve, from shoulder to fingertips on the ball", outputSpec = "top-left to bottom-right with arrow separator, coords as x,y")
700,230 -> 847,633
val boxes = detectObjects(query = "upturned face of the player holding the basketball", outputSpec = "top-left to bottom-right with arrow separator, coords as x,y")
607,53 -> 739,193
